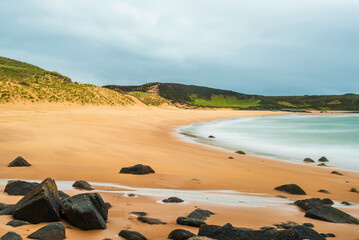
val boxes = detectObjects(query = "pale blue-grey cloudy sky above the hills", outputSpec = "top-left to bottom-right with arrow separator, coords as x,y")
0,0 -> 359,95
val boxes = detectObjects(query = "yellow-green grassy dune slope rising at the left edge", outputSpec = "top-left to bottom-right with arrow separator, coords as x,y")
0,57 -> 133,105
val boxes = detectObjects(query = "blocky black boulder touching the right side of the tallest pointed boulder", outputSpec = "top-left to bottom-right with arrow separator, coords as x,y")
61,193 -> 108,230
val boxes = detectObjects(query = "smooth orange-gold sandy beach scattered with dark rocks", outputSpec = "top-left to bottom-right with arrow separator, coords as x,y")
0,103 -> 359,240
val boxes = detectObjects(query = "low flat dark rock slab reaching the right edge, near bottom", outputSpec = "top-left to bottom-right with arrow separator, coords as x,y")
294,198 -> 359,224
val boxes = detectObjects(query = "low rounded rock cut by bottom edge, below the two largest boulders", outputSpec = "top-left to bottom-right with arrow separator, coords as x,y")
28,223 -> 66,240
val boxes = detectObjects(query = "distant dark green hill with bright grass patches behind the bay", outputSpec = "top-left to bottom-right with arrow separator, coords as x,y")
105,83 -> 359,110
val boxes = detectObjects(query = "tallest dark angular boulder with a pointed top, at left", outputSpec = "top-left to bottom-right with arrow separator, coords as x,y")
12,178 -> 61,224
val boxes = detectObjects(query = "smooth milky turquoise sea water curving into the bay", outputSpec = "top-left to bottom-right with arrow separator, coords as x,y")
180,114 -> 359,171
